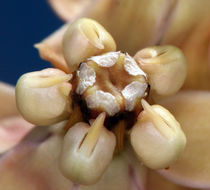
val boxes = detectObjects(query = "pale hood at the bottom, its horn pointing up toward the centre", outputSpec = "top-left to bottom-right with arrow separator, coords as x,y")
60,113 -> 116,185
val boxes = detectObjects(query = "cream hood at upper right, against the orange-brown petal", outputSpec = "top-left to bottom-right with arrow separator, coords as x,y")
134,45 -> 187,96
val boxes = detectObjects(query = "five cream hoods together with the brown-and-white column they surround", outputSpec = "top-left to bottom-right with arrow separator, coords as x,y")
16,18 -> 186,185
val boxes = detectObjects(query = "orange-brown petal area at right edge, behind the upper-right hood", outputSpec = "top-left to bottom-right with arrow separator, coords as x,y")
182,20 -> 210,90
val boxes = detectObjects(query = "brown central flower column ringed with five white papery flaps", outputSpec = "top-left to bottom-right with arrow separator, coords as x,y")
73,52 -> 148,129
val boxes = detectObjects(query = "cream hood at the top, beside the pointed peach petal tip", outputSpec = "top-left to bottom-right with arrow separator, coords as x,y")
63,18 -> 116,72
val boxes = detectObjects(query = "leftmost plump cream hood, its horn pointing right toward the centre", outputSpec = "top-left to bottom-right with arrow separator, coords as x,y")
16,69 -> 71,125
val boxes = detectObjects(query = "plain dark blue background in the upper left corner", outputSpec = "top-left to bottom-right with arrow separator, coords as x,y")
0,0 -> 63,85
